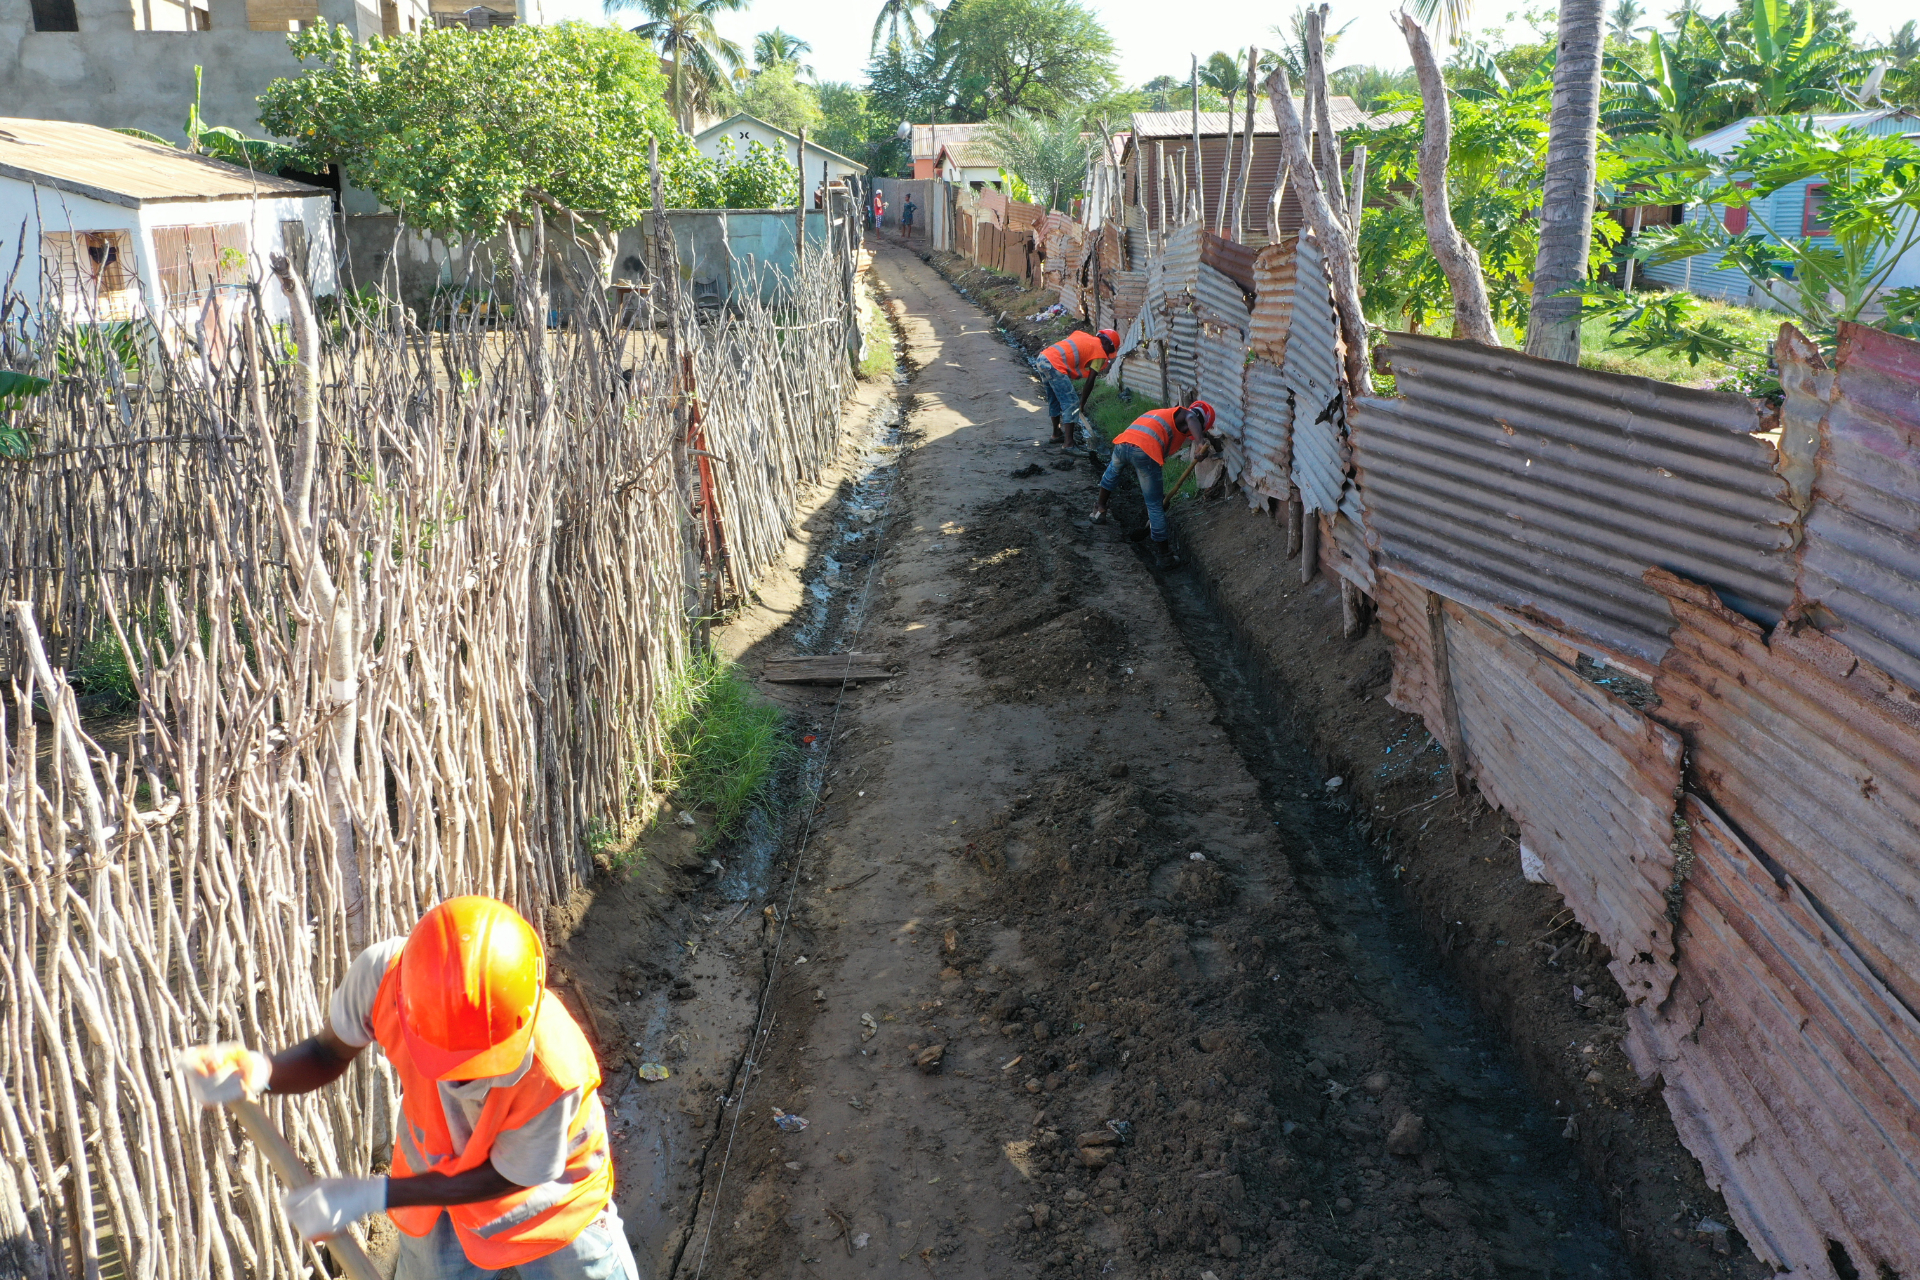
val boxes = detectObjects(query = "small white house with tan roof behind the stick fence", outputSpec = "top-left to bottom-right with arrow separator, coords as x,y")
0,117 -> 338,336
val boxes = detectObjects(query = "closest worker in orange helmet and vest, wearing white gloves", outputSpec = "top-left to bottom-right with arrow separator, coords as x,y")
180,898 -> 639,1280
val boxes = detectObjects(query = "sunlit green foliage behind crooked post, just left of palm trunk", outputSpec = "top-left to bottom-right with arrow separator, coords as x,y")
1346,75 -> 1619,330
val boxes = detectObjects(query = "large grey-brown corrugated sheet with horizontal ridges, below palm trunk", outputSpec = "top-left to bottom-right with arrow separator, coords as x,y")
1351,330 -> 1797,670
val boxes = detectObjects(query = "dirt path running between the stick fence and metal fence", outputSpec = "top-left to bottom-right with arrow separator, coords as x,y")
622,248 -> 1628,1280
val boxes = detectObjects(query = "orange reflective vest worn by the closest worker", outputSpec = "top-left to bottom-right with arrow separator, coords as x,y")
372,956 -> 612,1270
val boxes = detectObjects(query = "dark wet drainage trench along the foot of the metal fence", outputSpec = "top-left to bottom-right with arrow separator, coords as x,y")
1158,556 -> 1636,1280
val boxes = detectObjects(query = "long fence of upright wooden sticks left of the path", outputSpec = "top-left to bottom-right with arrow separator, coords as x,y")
0,214 -> 851,1280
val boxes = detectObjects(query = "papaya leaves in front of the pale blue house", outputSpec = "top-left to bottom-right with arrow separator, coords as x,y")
1590,119 -> 1920,345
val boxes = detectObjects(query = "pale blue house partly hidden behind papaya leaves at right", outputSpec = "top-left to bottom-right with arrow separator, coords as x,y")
1642,107 -> 1920,305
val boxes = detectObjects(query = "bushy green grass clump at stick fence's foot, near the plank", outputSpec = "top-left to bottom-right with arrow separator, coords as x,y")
655,654 -> 791,844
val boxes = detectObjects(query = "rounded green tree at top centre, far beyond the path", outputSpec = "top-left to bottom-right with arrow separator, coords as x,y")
929,0 -> 1119,119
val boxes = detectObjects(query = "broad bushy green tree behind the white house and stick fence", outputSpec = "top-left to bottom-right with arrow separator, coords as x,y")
259,21 -> 695,236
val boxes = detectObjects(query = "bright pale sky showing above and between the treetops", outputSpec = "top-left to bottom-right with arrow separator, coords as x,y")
543,0 -> 1916,86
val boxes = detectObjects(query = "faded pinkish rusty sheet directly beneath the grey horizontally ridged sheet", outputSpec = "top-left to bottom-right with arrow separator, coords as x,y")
1446,601 -> 1680,1006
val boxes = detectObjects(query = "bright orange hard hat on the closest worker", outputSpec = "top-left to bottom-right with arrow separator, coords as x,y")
399,896 -> 547,1080
